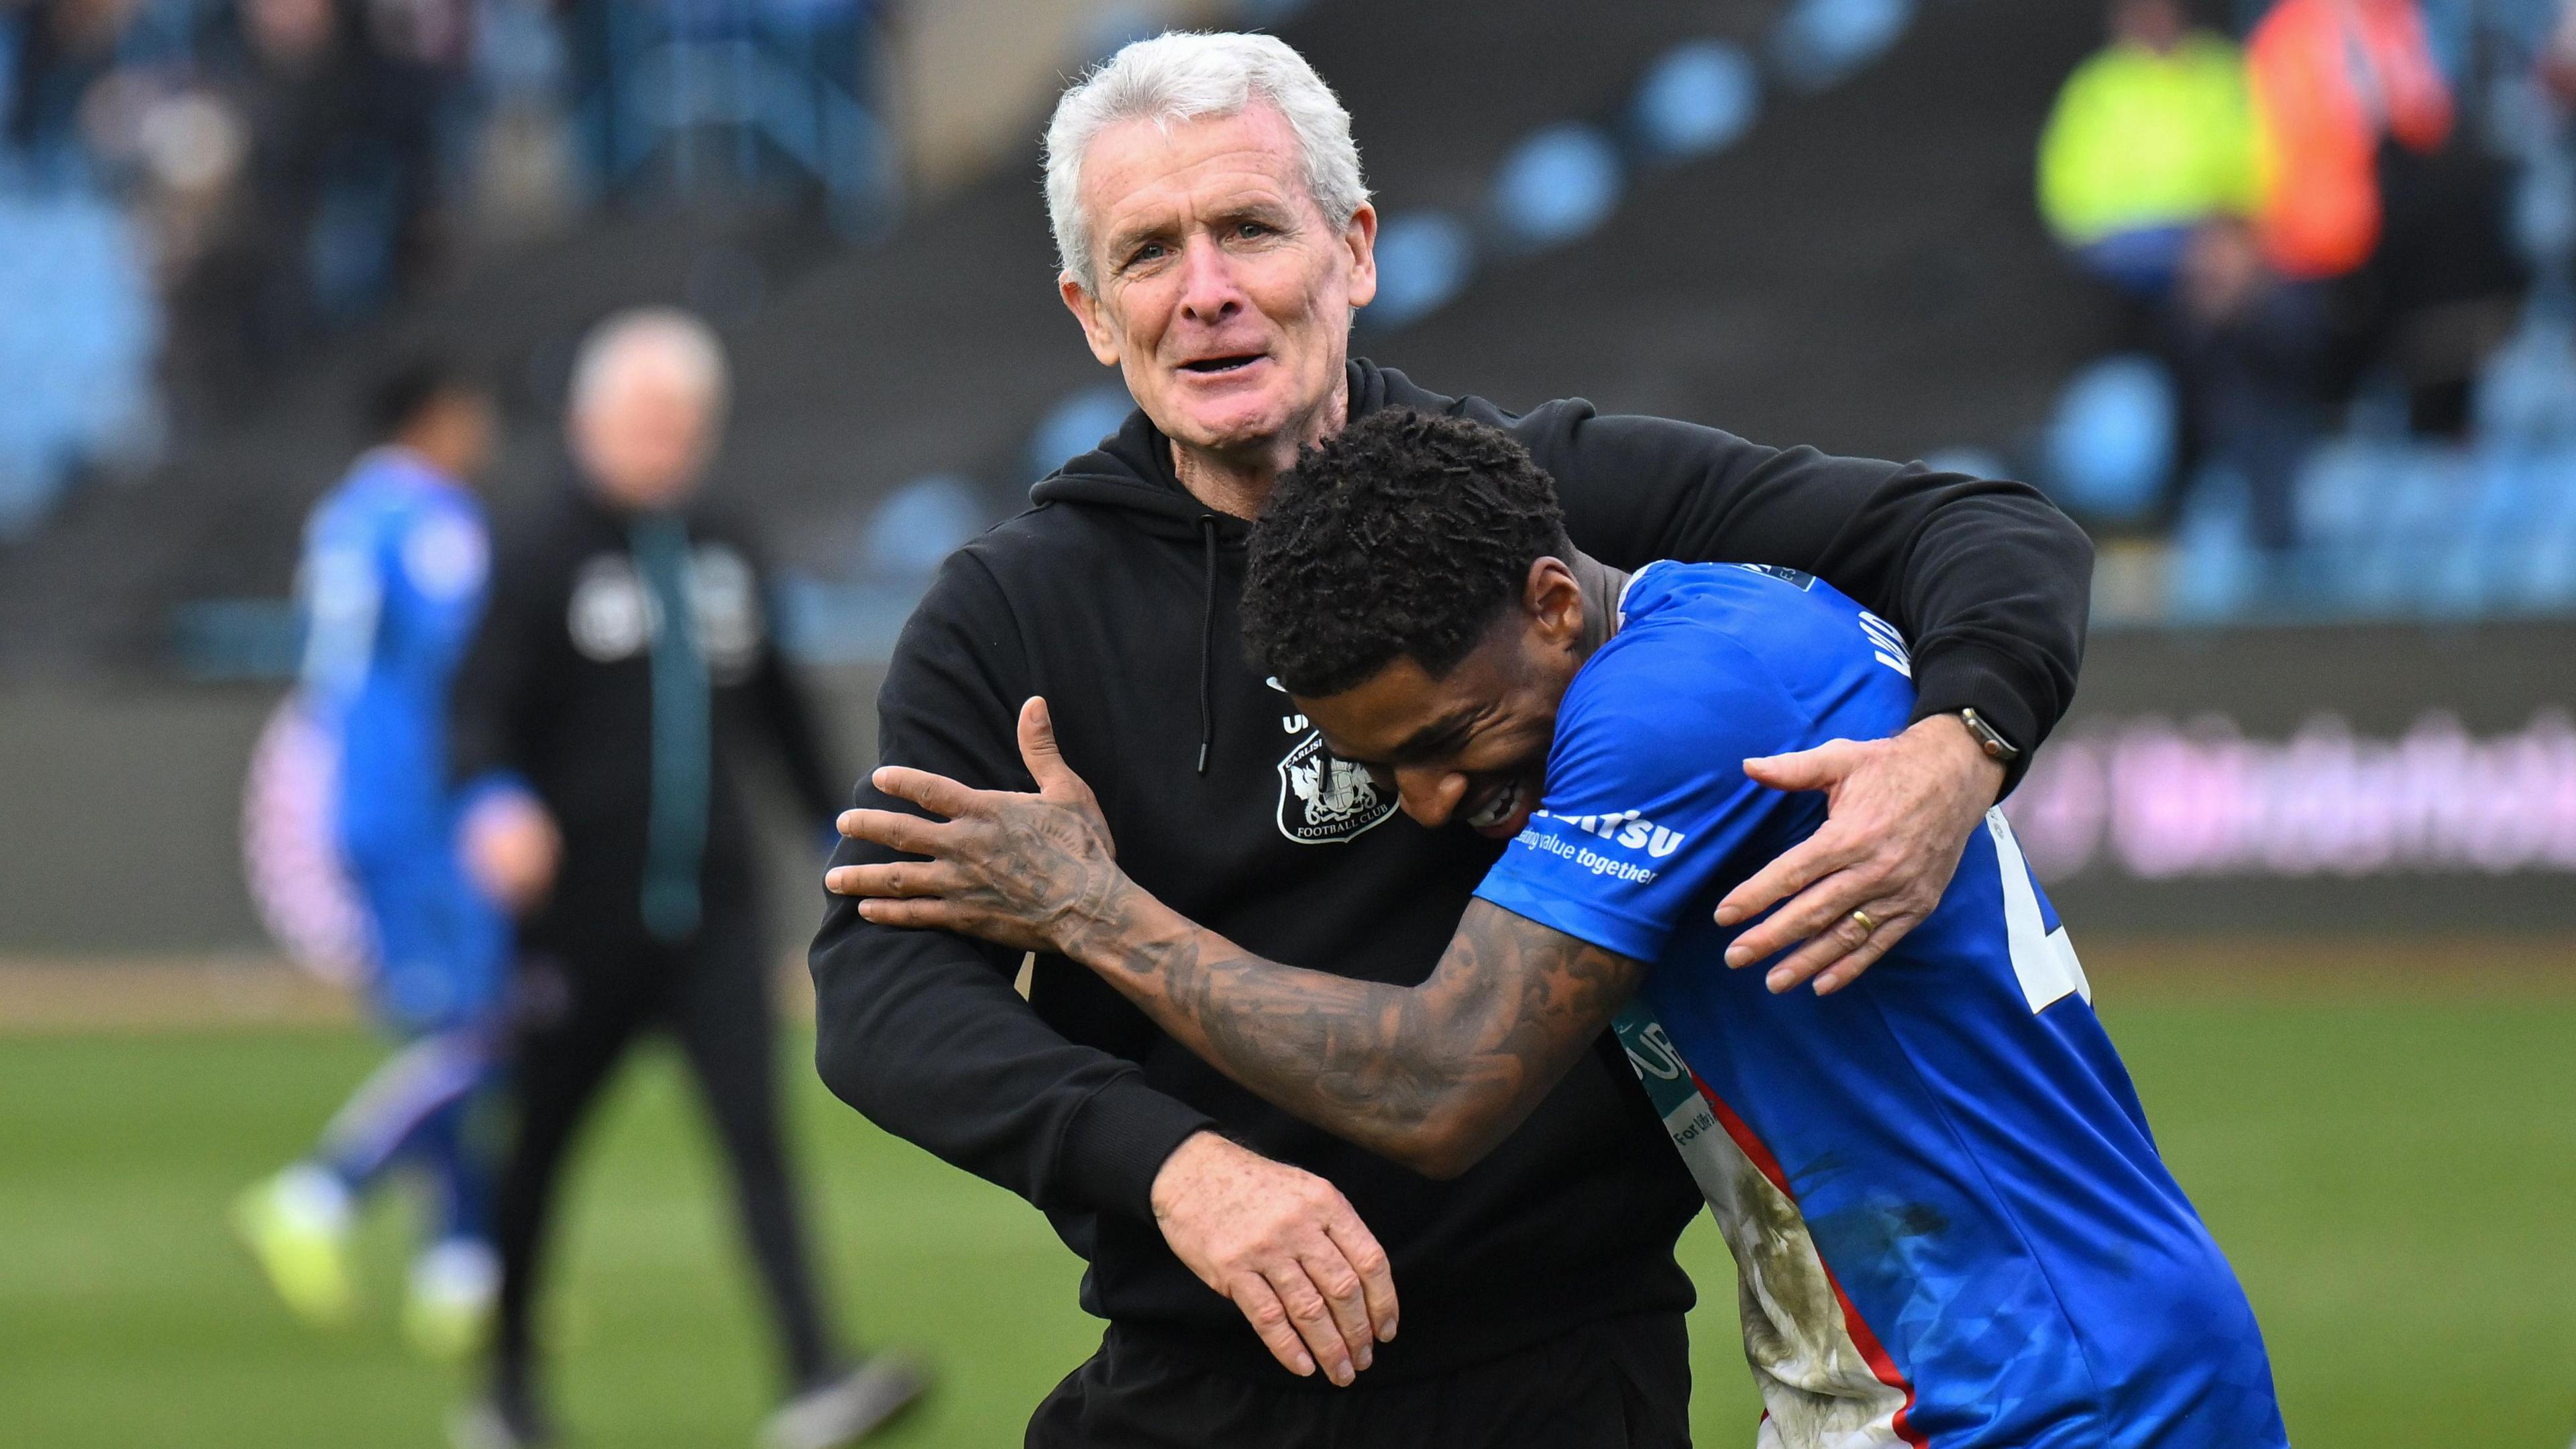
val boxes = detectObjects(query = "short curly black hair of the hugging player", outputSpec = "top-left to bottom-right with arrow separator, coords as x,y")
1244,407 -> 1566,699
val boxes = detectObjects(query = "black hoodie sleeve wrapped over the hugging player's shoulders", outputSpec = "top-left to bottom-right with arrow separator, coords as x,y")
1515,400 -> 2092,792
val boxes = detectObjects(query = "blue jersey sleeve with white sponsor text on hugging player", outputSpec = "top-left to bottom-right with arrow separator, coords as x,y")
1476,629 -> 1811,962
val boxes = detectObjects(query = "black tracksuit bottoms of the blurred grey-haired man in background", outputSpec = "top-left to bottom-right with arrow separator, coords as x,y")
494,898 -> 837,1403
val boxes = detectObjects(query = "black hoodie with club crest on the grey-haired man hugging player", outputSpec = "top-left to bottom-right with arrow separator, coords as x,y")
812,361 -> 2092,1385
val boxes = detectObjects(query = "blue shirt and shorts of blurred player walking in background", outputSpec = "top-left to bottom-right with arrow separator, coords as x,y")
301,449 -> 507,1026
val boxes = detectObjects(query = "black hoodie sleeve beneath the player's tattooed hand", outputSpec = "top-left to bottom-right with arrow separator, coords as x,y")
809,549 -> 1216,1222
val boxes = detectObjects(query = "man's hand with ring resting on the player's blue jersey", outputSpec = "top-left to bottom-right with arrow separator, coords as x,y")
1718,714 -> 2004,996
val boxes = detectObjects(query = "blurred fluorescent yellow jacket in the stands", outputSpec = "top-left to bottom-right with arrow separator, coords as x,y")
2040,31 -> 2257,248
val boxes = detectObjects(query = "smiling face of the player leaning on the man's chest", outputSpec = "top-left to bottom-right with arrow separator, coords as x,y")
1296,559 -> 1585,841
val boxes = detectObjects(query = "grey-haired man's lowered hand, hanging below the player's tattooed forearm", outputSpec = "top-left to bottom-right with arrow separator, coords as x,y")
1154,1132 -> 1396,1387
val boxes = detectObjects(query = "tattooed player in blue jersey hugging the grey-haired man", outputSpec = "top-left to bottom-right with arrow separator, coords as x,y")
832,410 -> 2285,1449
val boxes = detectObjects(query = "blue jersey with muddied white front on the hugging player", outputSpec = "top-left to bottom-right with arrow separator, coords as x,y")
1476,562 -> 2285,1449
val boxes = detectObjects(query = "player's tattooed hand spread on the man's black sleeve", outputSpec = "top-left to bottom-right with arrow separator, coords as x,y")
822,699 -> 1131,957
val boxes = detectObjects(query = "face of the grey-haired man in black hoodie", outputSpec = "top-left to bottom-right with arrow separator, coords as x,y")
1059,103 -> 1378,469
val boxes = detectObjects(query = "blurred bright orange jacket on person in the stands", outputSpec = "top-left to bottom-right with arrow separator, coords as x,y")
2246,0 -> 2453,281
